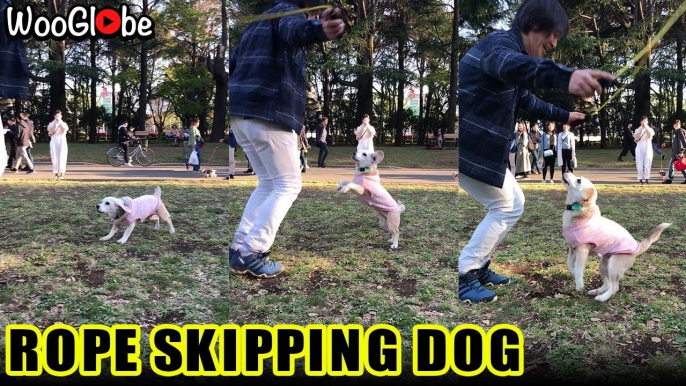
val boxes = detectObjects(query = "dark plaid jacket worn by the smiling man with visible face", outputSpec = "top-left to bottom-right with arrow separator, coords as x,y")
459,29 -> 573,188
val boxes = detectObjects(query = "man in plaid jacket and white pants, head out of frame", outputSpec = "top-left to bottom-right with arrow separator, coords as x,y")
229,0 -> 345,278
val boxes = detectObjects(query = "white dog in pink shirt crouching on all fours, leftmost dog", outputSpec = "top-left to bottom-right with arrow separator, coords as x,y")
97,186 -> 174,244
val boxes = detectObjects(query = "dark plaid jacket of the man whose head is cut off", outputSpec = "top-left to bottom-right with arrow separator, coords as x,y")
229,0 -> 327,134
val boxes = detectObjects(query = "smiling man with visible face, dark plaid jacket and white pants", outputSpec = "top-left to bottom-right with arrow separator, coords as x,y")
458,0 -> 615,303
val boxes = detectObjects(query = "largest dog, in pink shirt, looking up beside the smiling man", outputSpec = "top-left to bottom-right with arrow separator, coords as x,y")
562,172 -> 671,302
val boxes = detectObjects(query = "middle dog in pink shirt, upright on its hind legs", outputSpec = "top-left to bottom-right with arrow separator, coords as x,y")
338,151 -> 405,249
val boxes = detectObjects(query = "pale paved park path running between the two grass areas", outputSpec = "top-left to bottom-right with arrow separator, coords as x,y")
1,163 -> 682,185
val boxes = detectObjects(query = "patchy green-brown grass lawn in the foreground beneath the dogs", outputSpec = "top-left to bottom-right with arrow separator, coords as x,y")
0,179 -> 686,381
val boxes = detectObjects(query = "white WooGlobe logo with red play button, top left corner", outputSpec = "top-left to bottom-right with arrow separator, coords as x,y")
5,4 -> 155,40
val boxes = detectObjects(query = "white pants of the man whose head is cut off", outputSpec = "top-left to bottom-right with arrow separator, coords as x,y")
231,117 -> 302,256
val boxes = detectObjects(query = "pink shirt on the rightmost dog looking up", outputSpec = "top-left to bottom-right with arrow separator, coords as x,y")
562,216 -> 641,256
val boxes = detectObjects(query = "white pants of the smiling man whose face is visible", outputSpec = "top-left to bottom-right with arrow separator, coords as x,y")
458,170 -> 524,274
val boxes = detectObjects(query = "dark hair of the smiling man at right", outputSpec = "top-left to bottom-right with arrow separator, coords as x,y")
512,0 -> 569,40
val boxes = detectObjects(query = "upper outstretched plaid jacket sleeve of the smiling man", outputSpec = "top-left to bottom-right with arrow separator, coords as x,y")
481,34 -> 574,91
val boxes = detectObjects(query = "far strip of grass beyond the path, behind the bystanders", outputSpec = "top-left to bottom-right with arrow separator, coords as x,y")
2,141 -> 671,170
